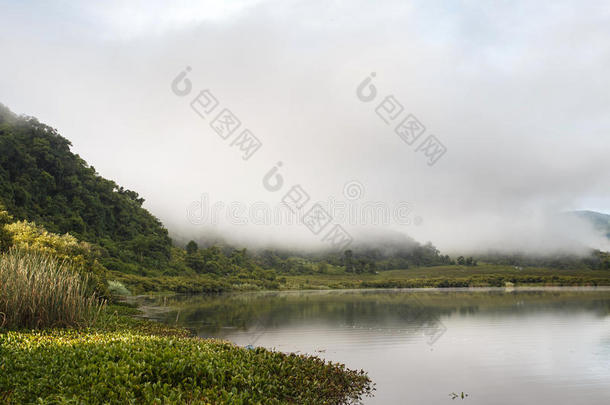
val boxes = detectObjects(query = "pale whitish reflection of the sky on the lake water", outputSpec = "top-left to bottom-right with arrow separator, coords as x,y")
224,313 -> 610,404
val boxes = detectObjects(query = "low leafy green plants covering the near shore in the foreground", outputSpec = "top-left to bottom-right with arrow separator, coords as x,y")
0,308 -> 372,404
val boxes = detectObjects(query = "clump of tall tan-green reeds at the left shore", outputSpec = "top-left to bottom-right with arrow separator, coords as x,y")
0,249 -> 104,328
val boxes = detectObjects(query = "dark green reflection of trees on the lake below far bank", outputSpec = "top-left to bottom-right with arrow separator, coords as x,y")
135,290 -> 610,335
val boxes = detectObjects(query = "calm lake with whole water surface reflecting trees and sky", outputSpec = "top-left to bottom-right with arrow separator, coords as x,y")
139,288 -> 610,405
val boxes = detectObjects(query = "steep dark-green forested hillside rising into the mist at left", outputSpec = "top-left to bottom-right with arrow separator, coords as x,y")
0,104 -> 171,272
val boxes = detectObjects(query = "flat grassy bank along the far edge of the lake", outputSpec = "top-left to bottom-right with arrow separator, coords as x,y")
114,264 -> 610,293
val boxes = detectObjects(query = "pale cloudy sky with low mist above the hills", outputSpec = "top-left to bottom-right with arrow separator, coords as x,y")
0,0 -> 610,252
